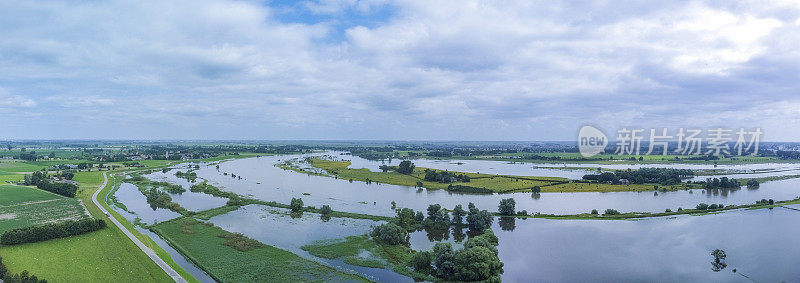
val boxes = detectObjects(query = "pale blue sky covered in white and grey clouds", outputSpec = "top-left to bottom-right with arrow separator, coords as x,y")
0,0 -> 800,141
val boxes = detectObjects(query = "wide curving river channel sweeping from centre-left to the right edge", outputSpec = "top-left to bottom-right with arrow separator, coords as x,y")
195,155 -> 800,216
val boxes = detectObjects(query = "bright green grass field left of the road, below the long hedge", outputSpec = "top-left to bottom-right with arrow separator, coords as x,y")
0,171 -> 172,282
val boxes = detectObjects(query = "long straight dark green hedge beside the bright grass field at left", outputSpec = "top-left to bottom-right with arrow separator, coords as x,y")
0,218 -> 106,245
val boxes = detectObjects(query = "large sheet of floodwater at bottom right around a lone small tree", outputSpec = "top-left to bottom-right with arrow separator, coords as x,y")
404,208 -> 800,282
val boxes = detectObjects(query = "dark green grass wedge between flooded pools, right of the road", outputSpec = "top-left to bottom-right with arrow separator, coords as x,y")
153,218 -> 366,282
